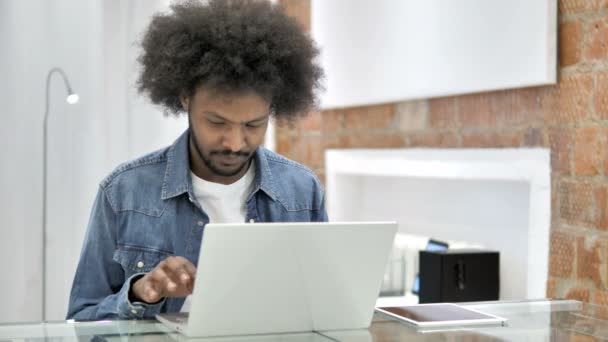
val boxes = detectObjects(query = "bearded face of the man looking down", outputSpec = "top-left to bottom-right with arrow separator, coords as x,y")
182,87 -> 270,184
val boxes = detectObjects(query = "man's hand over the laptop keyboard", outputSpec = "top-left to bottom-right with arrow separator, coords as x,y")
131,256 -> 196,303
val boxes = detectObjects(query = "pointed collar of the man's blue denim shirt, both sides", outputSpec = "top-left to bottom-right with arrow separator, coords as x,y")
161,130 -> 277,200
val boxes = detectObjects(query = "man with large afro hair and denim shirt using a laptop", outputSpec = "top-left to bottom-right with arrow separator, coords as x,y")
67,0 -> 327,320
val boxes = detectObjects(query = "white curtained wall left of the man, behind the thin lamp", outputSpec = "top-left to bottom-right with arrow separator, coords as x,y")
0,0 -> 187,322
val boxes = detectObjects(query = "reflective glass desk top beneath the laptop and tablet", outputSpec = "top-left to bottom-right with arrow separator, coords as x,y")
0,300 -> 608,342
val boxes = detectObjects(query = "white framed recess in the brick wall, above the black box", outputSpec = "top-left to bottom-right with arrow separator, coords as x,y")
325,148 -> 551,300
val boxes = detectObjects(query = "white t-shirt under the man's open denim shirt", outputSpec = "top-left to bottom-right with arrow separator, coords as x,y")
181,161 -> 255,312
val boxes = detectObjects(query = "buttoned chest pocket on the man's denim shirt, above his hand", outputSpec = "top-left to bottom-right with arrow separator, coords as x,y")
113,246 -> 172,278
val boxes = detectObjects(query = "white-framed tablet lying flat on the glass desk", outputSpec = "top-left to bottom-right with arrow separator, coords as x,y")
376,303 -> 507,328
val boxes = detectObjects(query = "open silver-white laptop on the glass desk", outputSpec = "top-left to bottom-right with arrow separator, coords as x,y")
156,222 -> 397,337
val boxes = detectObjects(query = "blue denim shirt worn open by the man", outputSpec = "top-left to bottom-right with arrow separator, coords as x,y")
67,131 -> 327,320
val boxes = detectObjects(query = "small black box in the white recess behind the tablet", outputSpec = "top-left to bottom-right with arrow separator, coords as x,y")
419,249 -> 500,303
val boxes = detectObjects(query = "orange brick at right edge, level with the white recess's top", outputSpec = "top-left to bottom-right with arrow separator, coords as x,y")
574,126 -> 605,176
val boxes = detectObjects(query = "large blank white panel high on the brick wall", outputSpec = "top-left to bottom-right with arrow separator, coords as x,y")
311,0 -> 557,108
